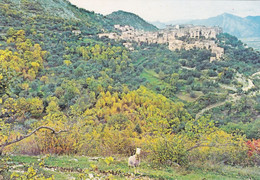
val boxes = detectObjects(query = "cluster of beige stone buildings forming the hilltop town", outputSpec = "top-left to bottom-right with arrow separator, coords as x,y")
99,25 -> 224,61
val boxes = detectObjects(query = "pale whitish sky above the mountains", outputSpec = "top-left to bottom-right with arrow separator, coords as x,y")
69,0 -> 260,22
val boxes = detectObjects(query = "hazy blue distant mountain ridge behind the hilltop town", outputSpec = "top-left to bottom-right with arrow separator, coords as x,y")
152,13 -> 260,38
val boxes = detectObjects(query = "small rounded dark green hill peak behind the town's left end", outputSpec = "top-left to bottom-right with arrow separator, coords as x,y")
106,11 -> 158,31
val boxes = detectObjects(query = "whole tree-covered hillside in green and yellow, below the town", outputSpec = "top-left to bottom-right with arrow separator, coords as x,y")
0,0 -> 260,179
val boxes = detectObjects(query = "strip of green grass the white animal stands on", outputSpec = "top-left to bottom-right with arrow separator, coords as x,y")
2,156 -> 260,180
